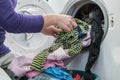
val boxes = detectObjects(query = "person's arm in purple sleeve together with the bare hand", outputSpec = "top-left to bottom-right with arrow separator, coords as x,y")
0,0 -> 77,36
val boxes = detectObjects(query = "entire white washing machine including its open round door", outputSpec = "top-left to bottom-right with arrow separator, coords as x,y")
5,0 -> 120,80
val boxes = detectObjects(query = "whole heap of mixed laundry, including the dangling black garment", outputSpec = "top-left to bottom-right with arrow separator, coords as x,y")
8,7 -> 104,80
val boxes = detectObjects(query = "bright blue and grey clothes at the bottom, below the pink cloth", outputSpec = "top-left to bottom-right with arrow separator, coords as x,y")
28,67 -> 74,80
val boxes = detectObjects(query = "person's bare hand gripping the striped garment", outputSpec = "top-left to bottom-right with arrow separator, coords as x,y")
41,14 -> 77,36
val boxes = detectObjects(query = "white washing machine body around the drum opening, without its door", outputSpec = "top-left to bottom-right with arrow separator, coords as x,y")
61,0 -> 120,80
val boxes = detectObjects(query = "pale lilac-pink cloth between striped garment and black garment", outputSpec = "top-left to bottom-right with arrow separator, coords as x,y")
82,25 -> 91,47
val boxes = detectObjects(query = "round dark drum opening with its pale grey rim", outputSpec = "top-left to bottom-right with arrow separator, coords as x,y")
62,0 -> 109,39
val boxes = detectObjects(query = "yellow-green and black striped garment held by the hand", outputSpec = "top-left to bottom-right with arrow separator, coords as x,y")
31,19 -> 88,72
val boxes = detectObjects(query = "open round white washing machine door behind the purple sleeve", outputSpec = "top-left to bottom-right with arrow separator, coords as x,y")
5,0 -> 54,54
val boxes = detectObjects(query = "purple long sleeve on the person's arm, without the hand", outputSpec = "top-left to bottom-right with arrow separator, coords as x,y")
0,0 -> 44,33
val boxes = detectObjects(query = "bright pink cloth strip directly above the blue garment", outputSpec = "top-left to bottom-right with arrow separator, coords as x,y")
44,60 -> 66,69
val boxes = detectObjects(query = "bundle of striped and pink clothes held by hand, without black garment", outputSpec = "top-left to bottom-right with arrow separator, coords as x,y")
9,19 -> 96,78
